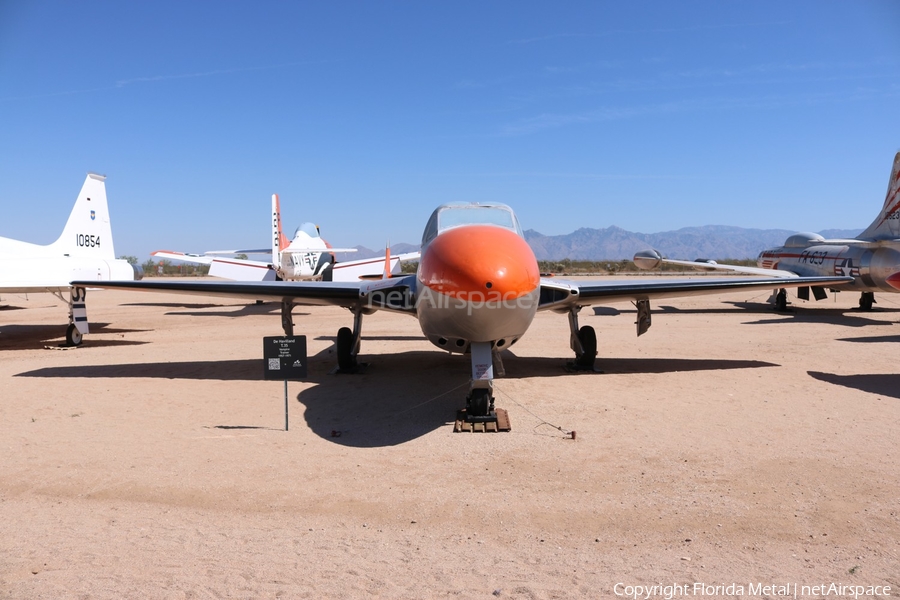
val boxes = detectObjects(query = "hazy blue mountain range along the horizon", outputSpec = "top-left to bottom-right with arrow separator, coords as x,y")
345,225 -> 862,260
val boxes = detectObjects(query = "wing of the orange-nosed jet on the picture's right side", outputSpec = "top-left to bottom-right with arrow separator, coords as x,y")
538,276 -> 853,311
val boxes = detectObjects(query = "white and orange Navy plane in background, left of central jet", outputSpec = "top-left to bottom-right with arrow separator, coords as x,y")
152,194 -> 419,281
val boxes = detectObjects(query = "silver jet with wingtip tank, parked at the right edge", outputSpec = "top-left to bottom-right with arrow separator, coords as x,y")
634,152 -> 900,311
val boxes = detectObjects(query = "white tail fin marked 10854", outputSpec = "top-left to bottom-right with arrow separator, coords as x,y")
51,173 -> 116,259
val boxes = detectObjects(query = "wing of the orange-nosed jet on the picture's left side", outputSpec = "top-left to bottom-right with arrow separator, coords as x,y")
72,275 -> 416,312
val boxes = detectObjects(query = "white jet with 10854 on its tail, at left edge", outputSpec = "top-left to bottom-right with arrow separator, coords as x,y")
0,173 -> 142,346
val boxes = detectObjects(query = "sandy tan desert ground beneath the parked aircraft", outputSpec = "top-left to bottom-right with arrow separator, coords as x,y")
0,278 -> 900,600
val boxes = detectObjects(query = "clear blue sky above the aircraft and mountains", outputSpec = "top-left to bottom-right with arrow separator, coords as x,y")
0,0 -> 900,260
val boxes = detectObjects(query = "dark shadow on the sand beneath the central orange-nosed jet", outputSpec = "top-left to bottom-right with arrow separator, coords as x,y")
15,348 -> 778,448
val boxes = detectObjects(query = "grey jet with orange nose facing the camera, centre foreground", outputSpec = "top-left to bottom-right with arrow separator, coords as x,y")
79,204 -> 850,417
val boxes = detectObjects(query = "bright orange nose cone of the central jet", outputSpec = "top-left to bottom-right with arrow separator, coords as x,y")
419,225 -> 541,302
